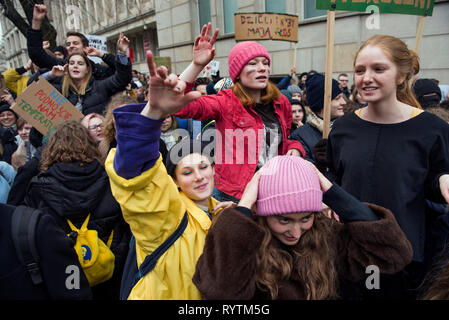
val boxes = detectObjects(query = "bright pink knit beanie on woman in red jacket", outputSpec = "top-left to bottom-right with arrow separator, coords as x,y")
228,41 -> 271,83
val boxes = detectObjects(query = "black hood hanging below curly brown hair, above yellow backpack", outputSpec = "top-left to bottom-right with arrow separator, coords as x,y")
32,161 -> 108,219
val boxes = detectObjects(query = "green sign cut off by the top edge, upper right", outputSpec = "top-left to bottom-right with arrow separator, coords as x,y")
316,0 -> 435,16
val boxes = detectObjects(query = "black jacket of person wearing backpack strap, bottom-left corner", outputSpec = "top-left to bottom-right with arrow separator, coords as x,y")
0,204 -> 92,300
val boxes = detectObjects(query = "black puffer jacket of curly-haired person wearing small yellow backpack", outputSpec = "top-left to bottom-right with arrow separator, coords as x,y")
25,161 -> 131,299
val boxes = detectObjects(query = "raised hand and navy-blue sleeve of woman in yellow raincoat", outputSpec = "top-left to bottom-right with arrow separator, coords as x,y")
110,51 -> 201,179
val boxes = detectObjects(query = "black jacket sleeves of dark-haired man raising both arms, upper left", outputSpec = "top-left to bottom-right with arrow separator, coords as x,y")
27,28 -> 115,80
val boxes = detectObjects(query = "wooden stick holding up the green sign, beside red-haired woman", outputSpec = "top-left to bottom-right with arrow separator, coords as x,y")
323,10 -> 335,139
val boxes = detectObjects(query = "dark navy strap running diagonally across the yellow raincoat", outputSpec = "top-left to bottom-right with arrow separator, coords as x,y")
120,212 -> 188,300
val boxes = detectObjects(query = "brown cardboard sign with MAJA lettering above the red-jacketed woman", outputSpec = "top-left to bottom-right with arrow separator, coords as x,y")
234,13 -> 298,42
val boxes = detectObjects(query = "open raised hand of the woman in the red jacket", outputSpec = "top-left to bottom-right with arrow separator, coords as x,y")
193,22 -> 219,67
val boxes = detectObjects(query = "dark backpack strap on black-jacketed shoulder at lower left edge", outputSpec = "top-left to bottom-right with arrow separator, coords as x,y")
11,206 -> 43,285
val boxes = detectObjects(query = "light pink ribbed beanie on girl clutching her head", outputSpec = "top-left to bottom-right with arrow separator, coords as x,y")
257,156 -> 323,216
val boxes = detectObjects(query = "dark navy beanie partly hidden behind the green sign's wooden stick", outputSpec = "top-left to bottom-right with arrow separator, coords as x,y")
306,73 -> 342,113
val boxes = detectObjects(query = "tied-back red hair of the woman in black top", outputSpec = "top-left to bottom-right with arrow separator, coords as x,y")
354,34 -> 422,109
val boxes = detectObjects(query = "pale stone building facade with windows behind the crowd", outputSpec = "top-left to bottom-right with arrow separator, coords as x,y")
2,0 -> 449,83
